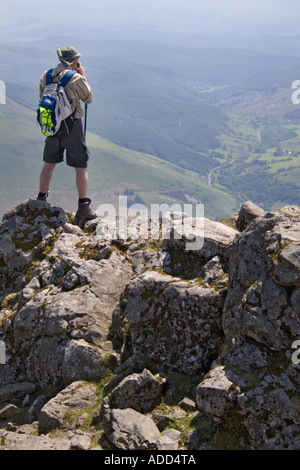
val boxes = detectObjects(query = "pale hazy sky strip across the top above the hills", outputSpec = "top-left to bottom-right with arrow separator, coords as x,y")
0,0 -> 300,40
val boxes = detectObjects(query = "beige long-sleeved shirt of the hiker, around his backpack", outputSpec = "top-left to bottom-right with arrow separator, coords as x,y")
39,63 -> 93,119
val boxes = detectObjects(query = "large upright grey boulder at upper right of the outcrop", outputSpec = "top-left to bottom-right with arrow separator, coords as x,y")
223,208 -> 300,350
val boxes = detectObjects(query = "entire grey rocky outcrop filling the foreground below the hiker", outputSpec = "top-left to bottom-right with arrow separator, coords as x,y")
0,200 -> 300,450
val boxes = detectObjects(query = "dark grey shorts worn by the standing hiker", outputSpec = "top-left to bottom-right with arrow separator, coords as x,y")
43,119 -> 89,168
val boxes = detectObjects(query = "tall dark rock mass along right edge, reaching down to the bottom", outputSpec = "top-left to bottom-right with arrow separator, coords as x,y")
204,206 -> 300,449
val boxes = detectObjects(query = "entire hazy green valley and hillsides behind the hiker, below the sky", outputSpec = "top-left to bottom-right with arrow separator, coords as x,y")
0,40 -> 300,218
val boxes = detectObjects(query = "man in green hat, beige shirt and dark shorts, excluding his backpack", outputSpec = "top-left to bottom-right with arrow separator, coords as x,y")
37,46 -> 97,223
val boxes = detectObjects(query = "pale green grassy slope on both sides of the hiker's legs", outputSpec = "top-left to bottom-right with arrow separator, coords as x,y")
0,99 -> 236,218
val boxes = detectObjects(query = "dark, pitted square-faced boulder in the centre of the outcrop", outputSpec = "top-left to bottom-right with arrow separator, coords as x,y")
113,271 -> 225,376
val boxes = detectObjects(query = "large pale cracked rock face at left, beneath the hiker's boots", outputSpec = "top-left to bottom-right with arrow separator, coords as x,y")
0,201 -> 131,387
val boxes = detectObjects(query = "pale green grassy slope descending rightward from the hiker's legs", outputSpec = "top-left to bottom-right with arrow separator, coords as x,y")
88,134 -> 236,218
